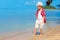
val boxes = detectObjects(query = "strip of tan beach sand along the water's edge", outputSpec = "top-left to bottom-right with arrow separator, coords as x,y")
0,26 -> 60,40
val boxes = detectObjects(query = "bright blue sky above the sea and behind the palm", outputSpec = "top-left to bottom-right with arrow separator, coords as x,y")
0,0 -> 60,8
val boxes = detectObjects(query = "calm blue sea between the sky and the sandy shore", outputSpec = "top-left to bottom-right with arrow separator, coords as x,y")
0,9 -> 60,34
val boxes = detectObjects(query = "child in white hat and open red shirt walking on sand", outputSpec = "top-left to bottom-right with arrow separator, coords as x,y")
34,2 -> 46,35
